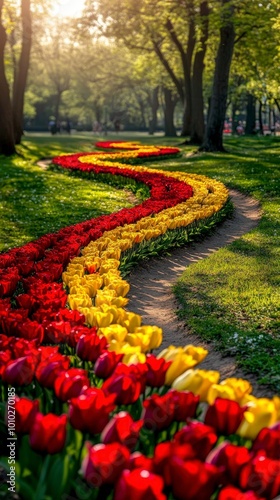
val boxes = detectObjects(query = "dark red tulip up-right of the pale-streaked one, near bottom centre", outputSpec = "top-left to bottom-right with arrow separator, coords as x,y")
141,392 -> 175,430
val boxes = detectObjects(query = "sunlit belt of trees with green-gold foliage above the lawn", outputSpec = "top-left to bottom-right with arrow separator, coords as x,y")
0,0 -> 280,154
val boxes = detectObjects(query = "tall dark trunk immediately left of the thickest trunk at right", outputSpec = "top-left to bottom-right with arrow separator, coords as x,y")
190,1 -> 209,146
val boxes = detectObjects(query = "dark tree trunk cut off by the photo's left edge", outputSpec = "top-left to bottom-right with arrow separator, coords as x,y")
0,0 -> 15,156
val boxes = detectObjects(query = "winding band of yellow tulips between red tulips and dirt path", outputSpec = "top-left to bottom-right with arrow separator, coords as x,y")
62,143 -> 280,438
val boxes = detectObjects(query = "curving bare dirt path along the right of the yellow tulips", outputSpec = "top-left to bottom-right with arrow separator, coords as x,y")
128,190 -> 272,397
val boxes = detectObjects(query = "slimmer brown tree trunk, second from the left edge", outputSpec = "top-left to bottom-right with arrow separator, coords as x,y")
13,0 -> 32,144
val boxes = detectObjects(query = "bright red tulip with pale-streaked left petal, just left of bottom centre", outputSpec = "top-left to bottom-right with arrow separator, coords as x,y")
101,411 -> 143,450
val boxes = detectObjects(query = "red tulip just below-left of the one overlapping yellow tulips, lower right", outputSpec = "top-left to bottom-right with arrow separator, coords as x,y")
174,422 -> 218,460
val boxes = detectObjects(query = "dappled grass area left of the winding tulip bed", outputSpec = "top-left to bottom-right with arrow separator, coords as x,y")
0,135 -> 140,251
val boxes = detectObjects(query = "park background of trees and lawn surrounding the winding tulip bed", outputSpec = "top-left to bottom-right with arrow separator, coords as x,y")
0,0 -> 280,500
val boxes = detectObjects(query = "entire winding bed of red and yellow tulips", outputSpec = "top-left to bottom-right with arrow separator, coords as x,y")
0,142 -> 280,500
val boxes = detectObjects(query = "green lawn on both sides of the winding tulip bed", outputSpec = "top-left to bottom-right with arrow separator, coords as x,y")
0,133 -> 280,392
